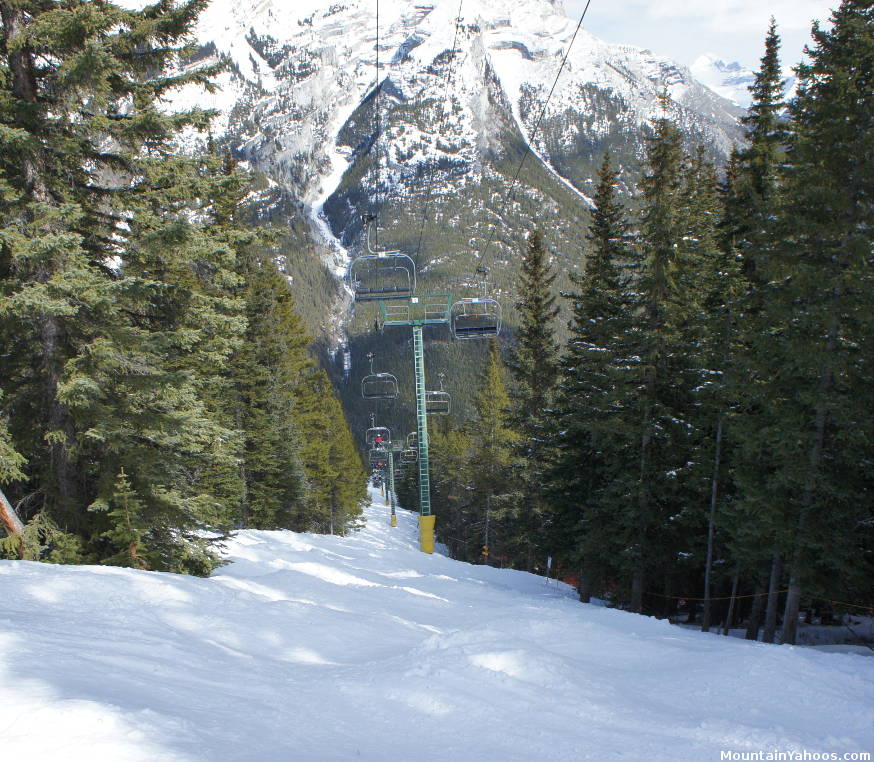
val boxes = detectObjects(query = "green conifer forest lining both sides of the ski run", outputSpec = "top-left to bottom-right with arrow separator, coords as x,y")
0,0 -> 874,643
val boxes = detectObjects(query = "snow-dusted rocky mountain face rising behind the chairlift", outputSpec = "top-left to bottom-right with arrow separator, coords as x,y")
179,0 -> 742,428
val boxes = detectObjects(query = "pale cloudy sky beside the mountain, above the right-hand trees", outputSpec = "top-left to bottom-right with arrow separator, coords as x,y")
564,0 -> 839,69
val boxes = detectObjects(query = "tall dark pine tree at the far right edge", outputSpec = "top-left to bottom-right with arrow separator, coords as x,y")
748,0 -> 874,643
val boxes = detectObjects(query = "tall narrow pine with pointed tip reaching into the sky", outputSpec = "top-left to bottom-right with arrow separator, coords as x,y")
708,19 -> 786,640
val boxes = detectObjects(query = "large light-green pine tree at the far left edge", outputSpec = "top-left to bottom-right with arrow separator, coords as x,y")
0,0 -> 215,523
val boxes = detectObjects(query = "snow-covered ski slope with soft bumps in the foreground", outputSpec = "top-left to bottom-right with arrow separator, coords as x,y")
0,486 -> 874,762
